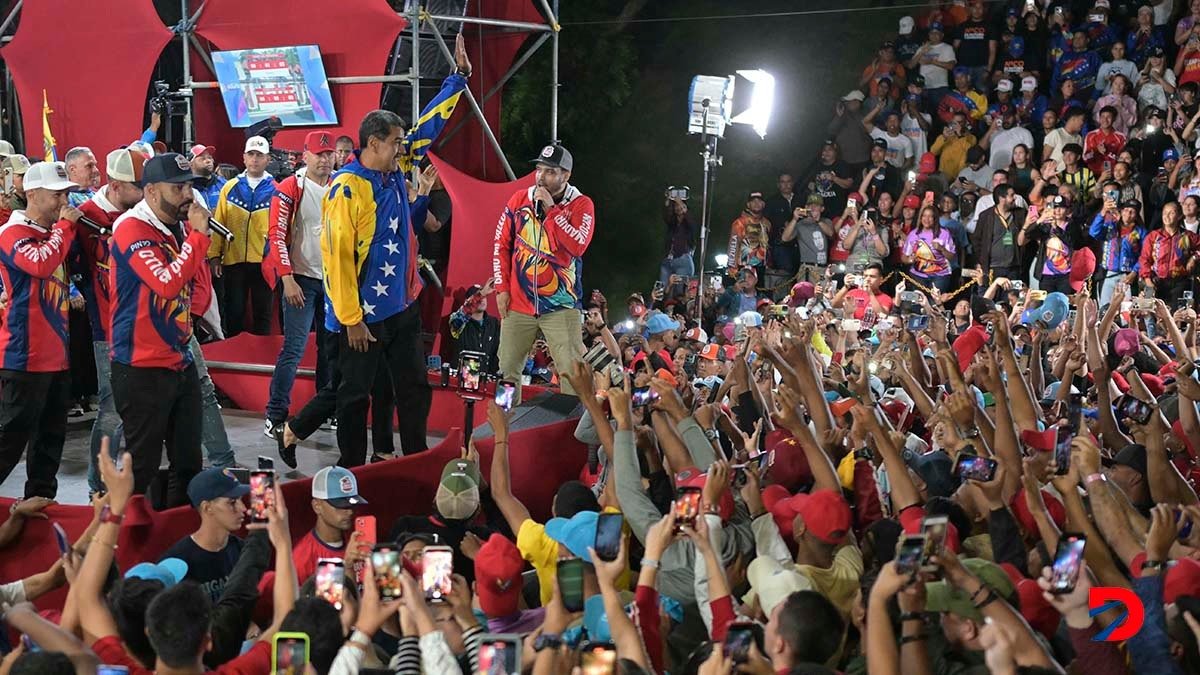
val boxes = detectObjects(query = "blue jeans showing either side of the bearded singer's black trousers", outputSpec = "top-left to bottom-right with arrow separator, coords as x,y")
88,335 -> 234,491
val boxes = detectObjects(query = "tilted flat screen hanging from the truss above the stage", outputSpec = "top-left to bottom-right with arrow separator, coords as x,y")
212,44 -> 337,127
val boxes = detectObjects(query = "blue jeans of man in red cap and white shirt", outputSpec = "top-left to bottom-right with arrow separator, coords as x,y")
266,275 -> 328,423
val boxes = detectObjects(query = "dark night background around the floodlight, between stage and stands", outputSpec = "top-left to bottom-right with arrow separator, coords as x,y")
502,0 -> 912,321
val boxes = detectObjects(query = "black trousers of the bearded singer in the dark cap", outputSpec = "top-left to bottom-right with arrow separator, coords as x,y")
113,362 -> 203,508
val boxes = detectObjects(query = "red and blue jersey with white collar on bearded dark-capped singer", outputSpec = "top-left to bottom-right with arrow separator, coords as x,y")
110,201 -> 209,370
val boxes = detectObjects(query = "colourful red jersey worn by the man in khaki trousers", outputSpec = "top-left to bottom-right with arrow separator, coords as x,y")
492,185 -> 595,316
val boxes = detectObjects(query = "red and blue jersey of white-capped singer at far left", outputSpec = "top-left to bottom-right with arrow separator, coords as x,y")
0,210 -> 74,372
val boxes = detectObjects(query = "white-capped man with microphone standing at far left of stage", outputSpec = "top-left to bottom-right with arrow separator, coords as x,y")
0,157 -> 82,498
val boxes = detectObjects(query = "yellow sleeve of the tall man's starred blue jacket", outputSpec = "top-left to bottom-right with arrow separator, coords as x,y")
320,175 -> 371,325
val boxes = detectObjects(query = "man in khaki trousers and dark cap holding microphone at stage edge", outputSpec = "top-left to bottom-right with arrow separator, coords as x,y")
492,144 -> 595,401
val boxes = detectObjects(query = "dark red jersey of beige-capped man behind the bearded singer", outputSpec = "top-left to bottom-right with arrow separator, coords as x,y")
72,185 -> 121,342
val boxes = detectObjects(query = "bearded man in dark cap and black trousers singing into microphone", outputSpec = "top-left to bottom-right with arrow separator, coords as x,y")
109,153 -> 209,508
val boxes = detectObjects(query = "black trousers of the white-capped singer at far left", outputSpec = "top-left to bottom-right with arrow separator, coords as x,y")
0,370 -> 71,500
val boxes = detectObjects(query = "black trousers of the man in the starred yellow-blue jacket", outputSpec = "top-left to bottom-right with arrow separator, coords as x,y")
337,303 -> 433,466
